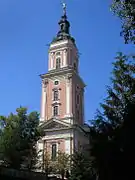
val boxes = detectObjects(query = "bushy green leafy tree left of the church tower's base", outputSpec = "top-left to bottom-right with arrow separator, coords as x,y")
0,107 -> 40,169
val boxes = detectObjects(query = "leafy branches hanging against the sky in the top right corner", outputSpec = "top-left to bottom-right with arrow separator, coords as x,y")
111,0 -> 135,44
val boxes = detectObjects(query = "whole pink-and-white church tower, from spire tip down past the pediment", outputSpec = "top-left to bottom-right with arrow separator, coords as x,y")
39,4 -> 88,160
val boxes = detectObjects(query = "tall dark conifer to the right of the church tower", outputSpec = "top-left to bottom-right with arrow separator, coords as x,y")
91,53 -> 135,180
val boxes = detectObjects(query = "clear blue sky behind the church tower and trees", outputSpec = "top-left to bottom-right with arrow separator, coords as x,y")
0,0 -> 132,120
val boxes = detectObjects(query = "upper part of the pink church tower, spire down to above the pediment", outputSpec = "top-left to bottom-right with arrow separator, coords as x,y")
41,4 -> 85,125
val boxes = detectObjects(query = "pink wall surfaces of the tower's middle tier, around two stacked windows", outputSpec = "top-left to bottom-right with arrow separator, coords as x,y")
44,71 -> 83,124
